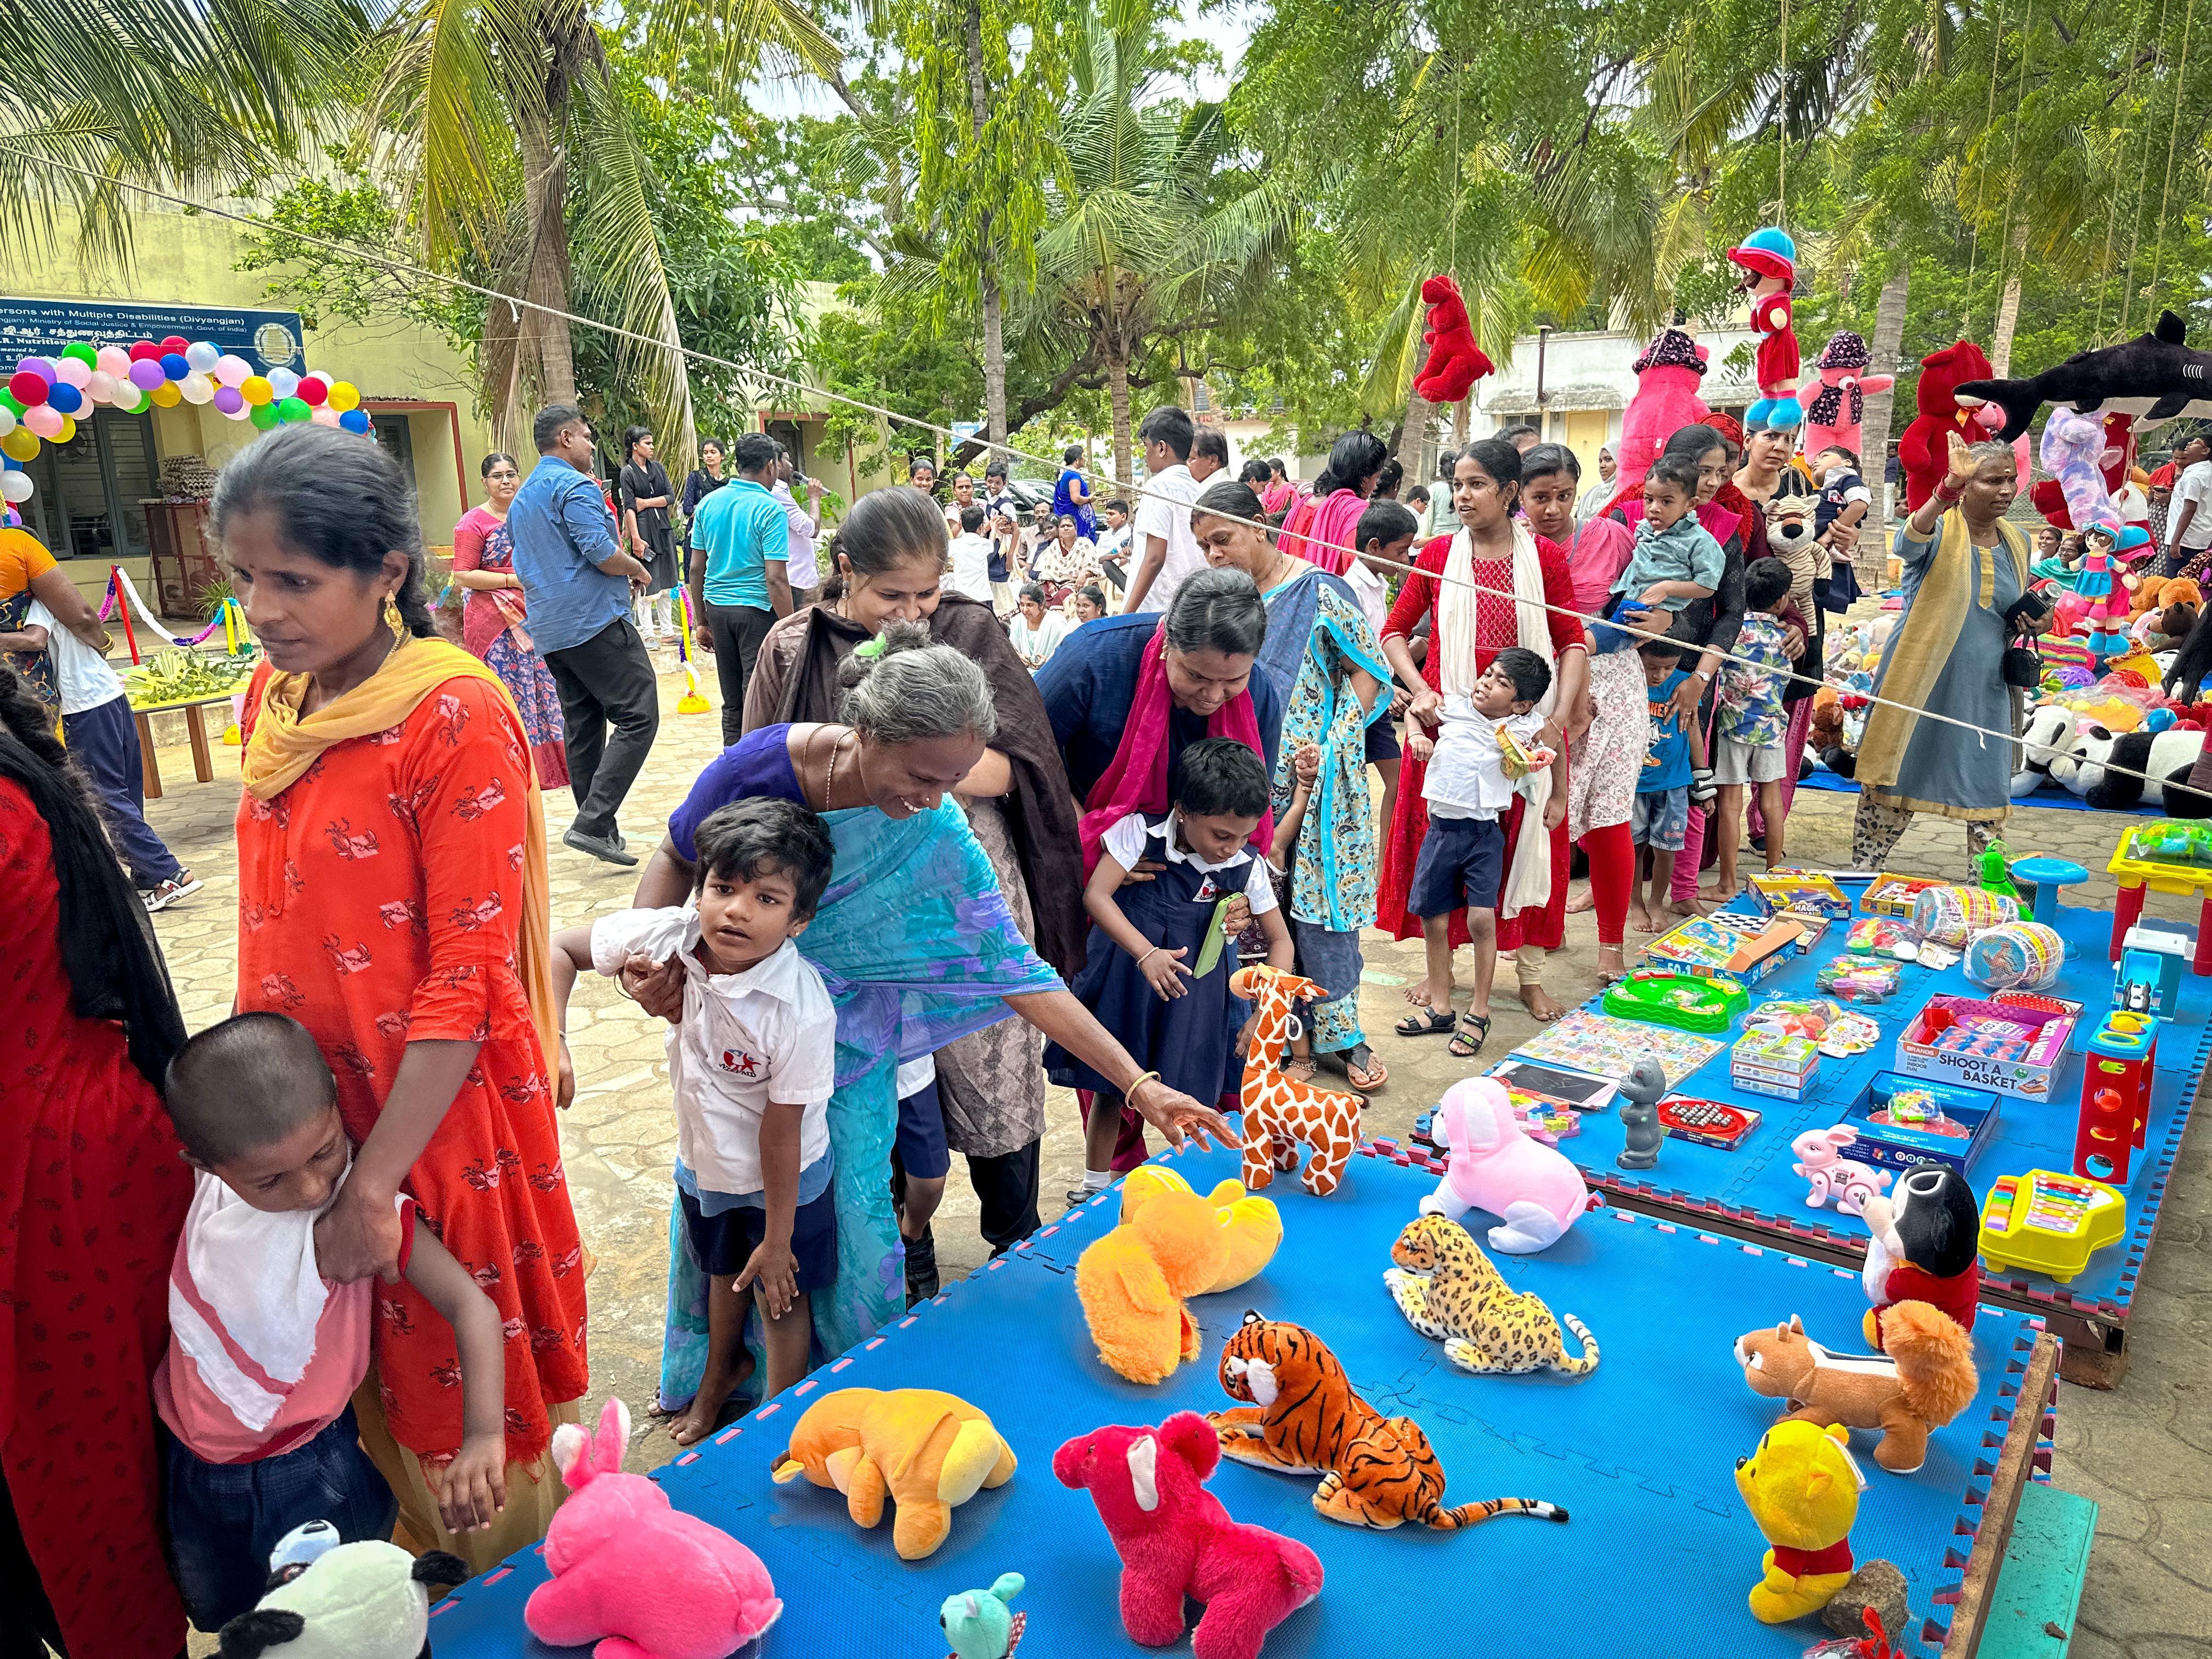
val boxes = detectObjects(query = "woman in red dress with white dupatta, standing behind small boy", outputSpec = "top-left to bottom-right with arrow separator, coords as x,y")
1376,438 -> 1588,1040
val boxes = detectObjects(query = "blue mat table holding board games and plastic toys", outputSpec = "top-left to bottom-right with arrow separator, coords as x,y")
1531,872 -> 2212,1387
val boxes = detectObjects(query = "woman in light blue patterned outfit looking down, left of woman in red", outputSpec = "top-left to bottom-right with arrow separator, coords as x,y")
1190,480 -> 1389,1093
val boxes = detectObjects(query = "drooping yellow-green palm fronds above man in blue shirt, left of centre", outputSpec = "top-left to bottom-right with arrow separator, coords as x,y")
360,0 -> 843,465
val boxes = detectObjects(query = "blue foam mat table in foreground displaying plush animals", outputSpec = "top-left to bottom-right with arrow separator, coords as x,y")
431,1153 -> 2051,1659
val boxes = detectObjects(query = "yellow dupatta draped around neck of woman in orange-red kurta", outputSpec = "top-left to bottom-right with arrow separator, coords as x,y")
244,635 -> 560,1075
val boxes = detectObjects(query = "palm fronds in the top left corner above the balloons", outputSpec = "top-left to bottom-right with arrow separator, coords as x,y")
0,0 -> 369,257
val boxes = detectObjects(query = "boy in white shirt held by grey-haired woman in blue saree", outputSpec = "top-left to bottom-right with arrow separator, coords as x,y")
553,800 -> 832,1447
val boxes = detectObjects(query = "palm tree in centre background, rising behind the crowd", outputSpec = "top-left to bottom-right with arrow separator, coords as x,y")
1015,11 -> 1296,480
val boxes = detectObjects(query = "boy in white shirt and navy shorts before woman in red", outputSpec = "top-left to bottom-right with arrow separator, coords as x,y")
1398,646 -> 1566,1059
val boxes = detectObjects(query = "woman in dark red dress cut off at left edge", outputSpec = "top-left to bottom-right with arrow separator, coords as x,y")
0,668 -> 193,1659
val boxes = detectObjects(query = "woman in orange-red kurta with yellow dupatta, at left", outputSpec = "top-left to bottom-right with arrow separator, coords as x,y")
215,425 -> 589,1568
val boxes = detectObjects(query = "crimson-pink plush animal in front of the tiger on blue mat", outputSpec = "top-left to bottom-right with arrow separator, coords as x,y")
1053,1411 -> 1321,1659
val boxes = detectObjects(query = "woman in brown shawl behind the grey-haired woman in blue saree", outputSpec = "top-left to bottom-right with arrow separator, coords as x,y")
746,489 -> 1086,1301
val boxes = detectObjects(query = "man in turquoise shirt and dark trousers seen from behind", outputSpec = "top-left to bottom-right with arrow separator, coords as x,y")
692,431 -> 792,743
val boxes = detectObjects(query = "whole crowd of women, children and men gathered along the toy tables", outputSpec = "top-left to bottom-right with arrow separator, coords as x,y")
0,374 -> 2079,1659
